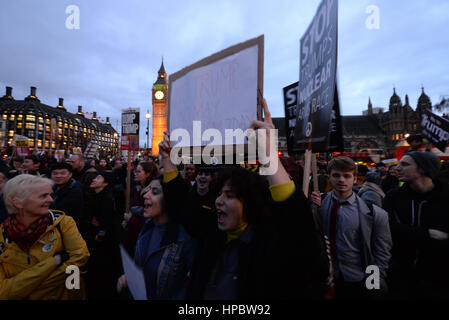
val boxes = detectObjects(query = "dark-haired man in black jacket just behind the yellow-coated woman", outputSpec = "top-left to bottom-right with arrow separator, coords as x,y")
50,162 -> 83,231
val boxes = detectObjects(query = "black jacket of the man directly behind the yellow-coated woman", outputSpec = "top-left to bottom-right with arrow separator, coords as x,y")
50,178 -> 84,229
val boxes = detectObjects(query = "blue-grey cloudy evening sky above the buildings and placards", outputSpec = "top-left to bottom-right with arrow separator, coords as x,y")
0,0 -> 449,145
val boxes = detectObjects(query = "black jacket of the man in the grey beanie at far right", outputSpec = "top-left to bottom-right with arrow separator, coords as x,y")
384,181 -> 449,290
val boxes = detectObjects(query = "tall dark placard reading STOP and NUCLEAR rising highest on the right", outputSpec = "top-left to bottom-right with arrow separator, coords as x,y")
293,0 -> 338,152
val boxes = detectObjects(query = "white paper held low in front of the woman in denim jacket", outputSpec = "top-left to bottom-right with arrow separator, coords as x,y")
120,246 -> 147,300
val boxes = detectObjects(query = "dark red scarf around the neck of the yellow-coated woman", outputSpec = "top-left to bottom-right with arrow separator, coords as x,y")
3,214 -> 50,252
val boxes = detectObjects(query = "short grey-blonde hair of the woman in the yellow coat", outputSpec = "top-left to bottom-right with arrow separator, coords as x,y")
3,174 -> 54,214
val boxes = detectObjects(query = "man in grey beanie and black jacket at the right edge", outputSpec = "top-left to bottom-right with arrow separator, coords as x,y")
384,151 -> 449,299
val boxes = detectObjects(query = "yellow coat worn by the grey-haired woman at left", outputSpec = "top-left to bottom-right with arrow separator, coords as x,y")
0,210 -> 89,300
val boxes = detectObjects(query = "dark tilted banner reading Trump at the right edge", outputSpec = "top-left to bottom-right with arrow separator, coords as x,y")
420,109 -> 449,152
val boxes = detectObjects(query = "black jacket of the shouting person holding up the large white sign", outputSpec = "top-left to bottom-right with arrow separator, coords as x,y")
164,176 -> 329,299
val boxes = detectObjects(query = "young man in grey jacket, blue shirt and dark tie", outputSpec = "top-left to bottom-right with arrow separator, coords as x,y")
321,157 -> 392,299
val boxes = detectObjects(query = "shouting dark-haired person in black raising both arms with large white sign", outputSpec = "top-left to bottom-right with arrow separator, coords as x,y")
159,99 -> 329,300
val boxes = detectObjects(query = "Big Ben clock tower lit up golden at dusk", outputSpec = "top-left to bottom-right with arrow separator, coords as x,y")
151,59 -> 168,156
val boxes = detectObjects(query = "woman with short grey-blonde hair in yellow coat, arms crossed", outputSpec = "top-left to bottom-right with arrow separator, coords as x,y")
0,174 -> 89,300
